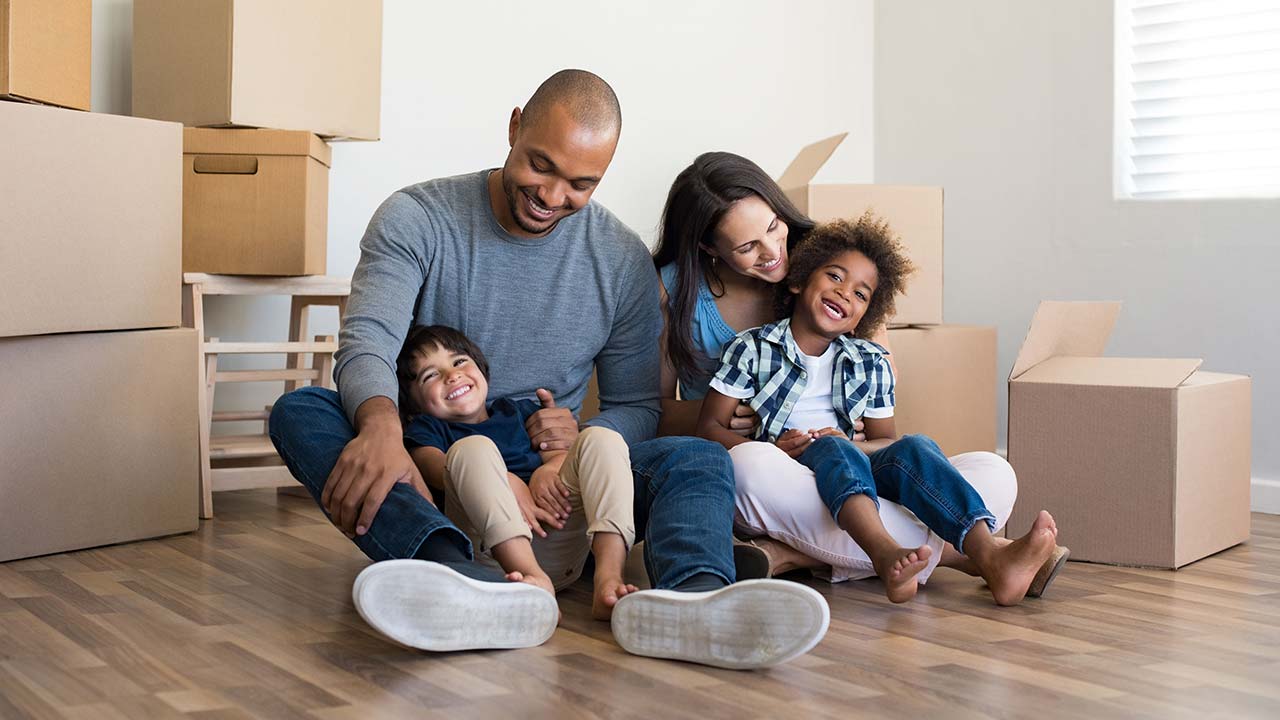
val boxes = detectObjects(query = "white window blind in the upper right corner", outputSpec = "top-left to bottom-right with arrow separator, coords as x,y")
1116,0 -> 1280,199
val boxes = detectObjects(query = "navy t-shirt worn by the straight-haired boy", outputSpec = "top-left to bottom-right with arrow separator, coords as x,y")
404,397 -> 543,483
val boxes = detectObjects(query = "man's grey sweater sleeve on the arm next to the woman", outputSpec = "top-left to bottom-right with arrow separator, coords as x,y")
586,254 -> 662,445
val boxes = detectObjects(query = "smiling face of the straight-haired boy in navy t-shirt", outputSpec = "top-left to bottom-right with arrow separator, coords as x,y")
410,346 -> 489,423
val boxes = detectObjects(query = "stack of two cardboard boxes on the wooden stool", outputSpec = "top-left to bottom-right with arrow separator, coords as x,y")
133,0 -> 383,275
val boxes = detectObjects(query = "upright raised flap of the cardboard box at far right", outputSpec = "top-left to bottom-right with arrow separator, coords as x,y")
1009,300 -> 1120,380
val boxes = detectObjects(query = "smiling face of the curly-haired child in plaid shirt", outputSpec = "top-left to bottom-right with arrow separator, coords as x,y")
790,250 -> 879,355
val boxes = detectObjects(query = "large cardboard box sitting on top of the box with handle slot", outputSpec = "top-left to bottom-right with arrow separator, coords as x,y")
133,0 -> 383,140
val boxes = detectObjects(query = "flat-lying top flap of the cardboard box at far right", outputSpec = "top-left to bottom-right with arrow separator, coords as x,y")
1018,355 -> 1201,388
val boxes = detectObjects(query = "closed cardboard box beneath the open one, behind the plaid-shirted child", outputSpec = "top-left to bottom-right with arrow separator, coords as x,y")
888,325 -> 996,456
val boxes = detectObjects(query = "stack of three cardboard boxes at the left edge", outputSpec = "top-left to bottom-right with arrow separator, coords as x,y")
0,0 -> 197,561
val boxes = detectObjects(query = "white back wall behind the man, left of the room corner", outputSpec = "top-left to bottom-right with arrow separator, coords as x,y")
93,0 -> 872,432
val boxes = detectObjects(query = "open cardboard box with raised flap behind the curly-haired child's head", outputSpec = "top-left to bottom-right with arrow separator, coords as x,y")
778,133 -> 942,325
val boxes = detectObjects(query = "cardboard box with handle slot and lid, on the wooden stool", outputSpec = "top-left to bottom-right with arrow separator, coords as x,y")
182,128 -> 332,275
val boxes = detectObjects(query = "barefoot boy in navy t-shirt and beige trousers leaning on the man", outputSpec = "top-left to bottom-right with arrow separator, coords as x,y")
397,325 -> 636,620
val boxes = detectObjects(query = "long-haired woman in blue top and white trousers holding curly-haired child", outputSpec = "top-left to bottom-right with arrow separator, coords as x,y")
654,152 -> 1065,596
